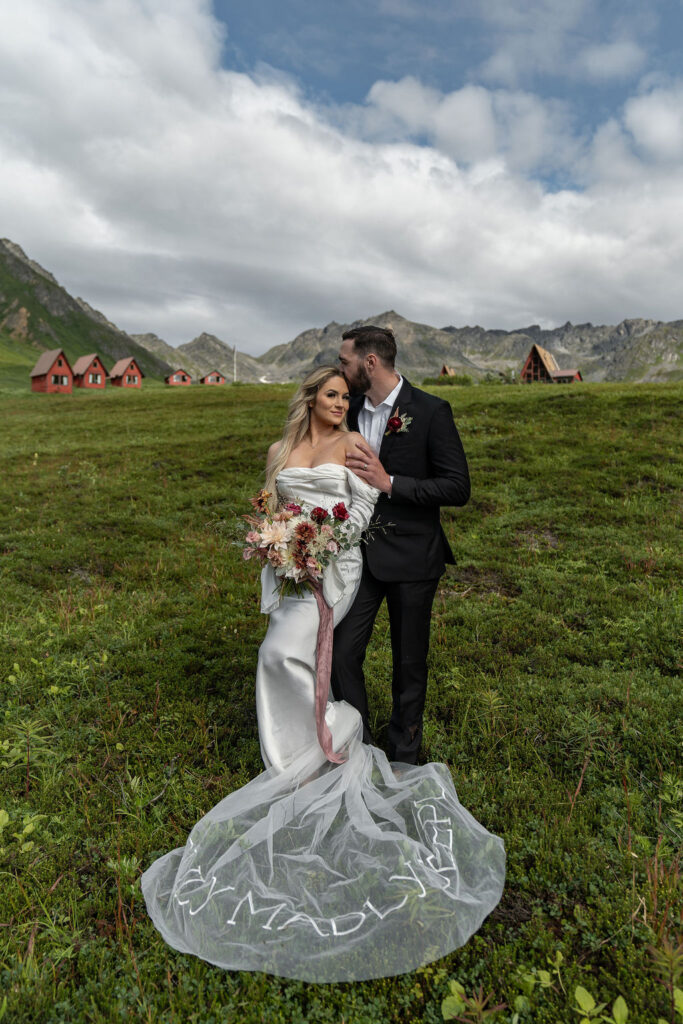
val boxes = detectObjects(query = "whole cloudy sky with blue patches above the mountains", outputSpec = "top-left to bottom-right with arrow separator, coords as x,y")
0,0 -> 683,354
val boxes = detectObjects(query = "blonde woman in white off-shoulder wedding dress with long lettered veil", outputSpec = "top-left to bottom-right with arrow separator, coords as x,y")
141,367 -> 505,982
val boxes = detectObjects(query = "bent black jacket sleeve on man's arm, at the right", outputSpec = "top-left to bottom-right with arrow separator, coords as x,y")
390,401 -> 470,505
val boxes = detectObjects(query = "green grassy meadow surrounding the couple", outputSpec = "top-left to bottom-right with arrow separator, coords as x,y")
0,380 -> 683,1024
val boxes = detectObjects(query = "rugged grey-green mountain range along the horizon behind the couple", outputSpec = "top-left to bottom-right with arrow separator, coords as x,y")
0,239 -> 683,382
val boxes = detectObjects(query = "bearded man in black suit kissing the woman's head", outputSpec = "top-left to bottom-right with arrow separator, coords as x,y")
332,327 -> 470,764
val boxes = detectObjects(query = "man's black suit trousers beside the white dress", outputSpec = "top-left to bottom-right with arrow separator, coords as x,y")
332,563 -> 438,764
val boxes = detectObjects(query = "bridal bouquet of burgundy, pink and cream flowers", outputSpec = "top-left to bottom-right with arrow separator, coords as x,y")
243,490 -> 357,592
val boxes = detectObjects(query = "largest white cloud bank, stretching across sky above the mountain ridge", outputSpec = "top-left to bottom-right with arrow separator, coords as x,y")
0,0 -> 683,352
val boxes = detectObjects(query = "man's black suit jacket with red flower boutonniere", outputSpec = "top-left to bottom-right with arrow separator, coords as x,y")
348,378 -> 470,583
